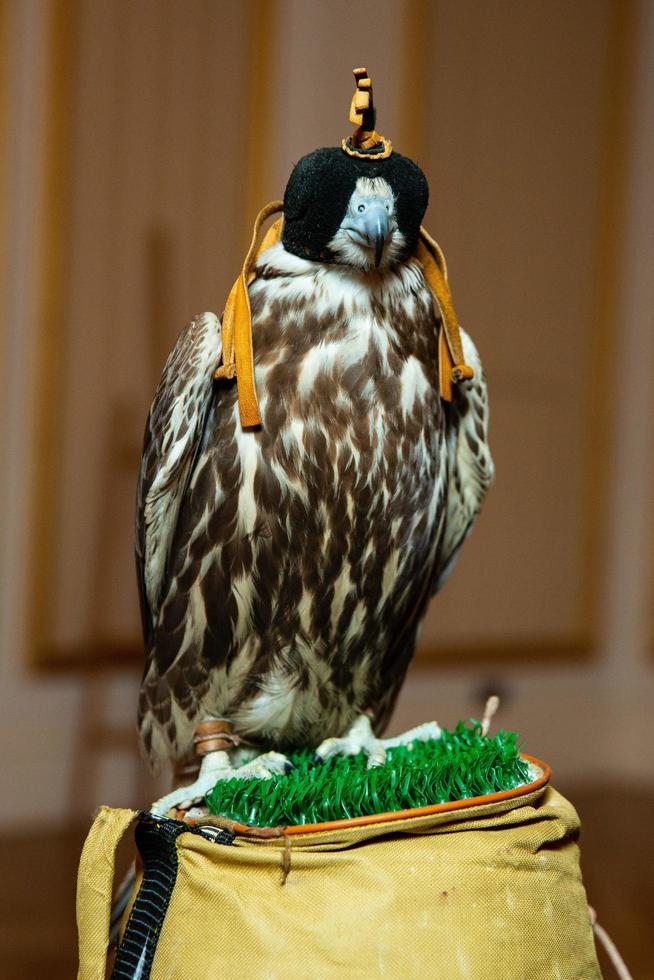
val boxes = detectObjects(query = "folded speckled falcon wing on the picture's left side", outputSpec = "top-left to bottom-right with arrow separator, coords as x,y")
135,313 -> 222,643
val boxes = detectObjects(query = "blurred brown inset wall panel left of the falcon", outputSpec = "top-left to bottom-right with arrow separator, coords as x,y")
32,0 -> 253,660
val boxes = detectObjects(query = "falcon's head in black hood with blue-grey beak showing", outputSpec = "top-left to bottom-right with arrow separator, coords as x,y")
282,147 -> 429,270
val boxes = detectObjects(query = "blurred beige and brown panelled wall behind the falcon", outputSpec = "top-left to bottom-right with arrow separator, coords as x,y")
0,0 -> 654,976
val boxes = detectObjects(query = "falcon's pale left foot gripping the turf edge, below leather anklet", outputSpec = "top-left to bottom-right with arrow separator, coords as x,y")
150,750 -> 294,817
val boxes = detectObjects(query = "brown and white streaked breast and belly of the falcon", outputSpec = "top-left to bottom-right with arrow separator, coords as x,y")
140,245 -> 456,757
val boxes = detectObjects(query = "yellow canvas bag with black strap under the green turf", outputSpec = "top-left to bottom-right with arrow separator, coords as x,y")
77,764 -> 601,980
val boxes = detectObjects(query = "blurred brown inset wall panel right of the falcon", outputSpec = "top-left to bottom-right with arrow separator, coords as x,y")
422,2 -> 615,655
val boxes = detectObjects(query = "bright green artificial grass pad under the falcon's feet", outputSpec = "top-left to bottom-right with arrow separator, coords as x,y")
206,720 -> 529,827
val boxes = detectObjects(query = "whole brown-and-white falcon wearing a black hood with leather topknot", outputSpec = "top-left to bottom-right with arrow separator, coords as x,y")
136,69 -> 493,812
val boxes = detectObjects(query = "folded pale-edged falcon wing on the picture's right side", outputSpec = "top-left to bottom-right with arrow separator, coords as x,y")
432,330 -> 494,595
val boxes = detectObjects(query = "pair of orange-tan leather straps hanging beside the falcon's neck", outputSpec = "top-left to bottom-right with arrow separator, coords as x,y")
214,201 -> 473,427
